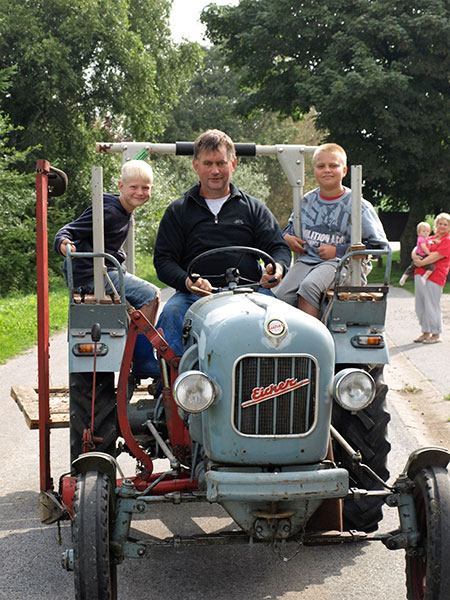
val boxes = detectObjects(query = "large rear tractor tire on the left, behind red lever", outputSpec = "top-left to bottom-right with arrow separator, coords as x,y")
69,372 -> 118,464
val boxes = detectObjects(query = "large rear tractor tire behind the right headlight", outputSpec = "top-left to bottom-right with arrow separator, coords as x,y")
332,365 -> 391,533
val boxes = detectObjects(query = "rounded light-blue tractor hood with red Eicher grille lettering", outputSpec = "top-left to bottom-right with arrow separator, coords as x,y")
179,290 -> 334,465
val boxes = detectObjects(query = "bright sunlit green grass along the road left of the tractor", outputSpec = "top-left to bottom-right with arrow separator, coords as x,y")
0,256 -> 164,364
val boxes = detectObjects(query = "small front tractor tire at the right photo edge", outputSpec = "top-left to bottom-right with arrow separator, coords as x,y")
406,467 -> 450,600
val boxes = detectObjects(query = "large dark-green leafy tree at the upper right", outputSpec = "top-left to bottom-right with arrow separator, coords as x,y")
202,0 -> 450,261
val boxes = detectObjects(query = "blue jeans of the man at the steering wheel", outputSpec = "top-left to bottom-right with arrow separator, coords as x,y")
156,287 -> 273,356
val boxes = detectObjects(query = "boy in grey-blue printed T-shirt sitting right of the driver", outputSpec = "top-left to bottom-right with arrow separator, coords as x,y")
274,143 -> 387,317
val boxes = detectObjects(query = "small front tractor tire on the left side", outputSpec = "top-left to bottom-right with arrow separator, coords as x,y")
72,471 -> 117,600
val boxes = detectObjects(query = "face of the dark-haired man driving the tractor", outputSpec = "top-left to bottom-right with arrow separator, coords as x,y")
192,146 -> 236,199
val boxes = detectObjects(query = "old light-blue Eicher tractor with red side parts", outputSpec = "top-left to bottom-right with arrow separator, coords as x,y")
34,143 -> 450,600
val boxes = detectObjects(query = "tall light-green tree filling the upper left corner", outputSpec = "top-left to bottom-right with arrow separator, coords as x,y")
0,0 -> 198,211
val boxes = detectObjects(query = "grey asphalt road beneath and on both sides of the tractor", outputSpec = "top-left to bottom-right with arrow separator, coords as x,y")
0,290 -> 450,600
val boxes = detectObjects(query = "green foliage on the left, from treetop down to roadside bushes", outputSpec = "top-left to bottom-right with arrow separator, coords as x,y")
0,0 -> 200,295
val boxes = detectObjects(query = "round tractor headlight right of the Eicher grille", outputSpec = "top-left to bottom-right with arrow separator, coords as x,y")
333,369 -> 375,411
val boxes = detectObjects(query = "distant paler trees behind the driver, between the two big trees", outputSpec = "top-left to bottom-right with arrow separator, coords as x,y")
162,46 -> 318,225
